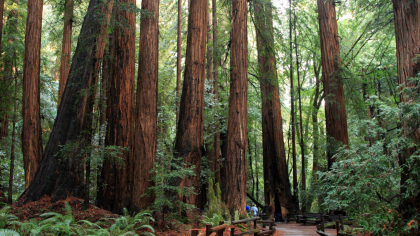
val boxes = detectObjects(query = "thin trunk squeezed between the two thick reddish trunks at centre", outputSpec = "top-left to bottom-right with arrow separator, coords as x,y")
212,0 -> 221,184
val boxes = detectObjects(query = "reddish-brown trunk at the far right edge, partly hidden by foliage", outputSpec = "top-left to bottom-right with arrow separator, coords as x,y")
392,0 -> 420,220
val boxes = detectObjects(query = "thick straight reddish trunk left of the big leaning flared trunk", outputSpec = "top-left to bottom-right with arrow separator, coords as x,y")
22,0 -> 42,187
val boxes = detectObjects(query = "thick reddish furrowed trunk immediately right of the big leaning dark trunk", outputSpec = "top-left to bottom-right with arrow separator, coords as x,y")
97,0 -> 135,214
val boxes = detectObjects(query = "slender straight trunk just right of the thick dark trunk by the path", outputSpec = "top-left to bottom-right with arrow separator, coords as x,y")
289,0 -> 298,200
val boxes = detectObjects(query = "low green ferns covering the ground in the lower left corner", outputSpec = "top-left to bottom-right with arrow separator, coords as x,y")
0,202 -> 155,236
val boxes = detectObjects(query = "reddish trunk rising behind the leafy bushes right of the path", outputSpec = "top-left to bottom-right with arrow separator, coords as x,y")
317,0 -> 349,169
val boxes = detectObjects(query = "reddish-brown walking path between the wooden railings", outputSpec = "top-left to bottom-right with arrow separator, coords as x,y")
276,223 -> 337,236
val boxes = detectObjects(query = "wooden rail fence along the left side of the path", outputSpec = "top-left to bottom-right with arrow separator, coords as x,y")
191,217 -> 276,236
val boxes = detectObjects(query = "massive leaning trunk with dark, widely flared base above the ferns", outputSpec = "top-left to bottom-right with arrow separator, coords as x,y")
21,0 -> 112,202
